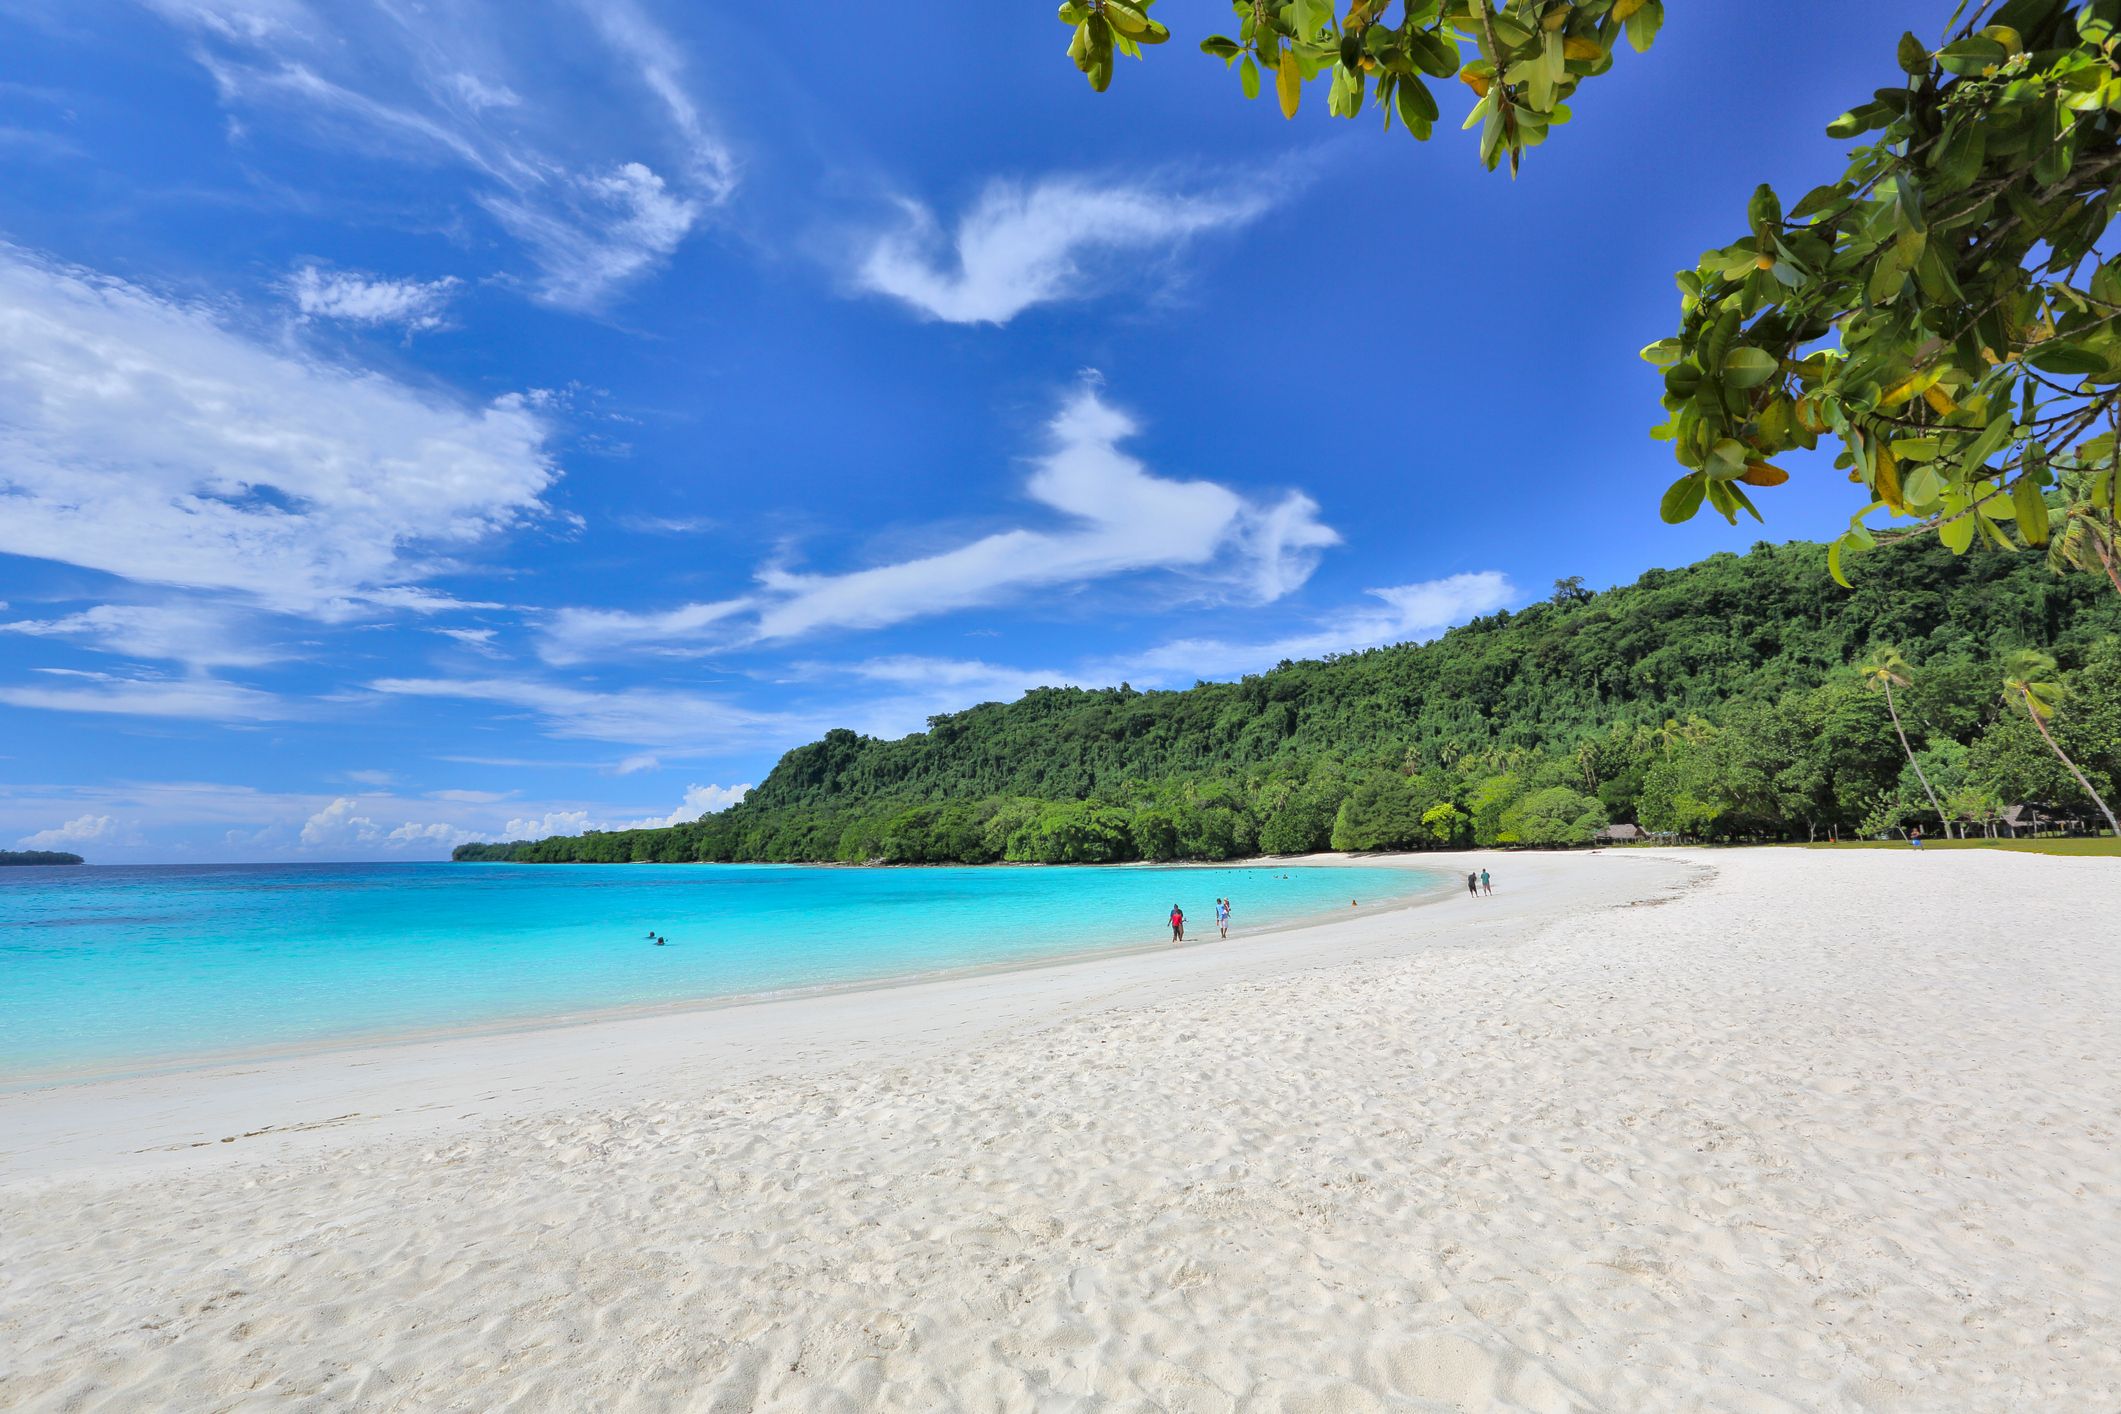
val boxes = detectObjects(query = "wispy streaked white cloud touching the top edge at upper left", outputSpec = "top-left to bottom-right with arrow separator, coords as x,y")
142,0 -> 736,307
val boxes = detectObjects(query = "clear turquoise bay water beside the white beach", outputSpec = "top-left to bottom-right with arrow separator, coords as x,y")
0,865 -> 1440,1081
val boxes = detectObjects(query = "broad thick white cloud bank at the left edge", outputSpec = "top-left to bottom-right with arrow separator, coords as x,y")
0,246 -> 558,615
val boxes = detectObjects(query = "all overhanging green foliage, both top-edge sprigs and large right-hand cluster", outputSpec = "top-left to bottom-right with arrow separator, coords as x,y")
1061,0 -> 2121,594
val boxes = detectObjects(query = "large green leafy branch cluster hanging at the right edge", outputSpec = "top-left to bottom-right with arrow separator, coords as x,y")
1644,0 -> 2121,589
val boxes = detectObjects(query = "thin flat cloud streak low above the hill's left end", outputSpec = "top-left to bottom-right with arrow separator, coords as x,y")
369,678 -> 785,748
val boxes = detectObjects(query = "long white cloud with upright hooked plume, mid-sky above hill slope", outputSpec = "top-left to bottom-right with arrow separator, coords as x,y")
541,384 -> 1340,664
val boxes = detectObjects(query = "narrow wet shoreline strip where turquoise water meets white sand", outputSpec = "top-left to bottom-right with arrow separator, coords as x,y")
0,852 -> 1451,1098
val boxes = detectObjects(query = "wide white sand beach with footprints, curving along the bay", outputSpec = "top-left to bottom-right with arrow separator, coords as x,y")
0,850 -> 2121,1414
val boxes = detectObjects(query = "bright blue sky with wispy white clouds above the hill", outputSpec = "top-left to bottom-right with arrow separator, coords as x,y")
0,0 -> 1945,863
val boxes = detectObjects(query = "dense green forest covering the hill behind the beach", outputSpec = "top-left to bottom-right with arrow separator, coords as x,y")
456,543 -> 2121,863
